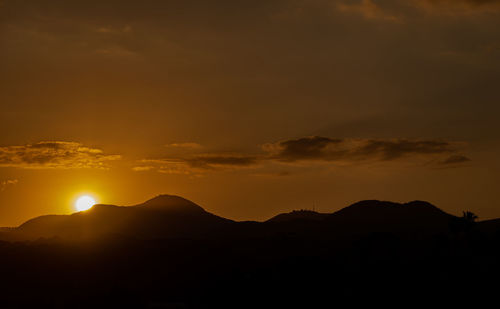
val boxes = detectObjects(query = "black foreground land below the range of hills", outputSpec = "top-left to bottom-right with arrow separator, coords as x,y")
0,195 -> 500,308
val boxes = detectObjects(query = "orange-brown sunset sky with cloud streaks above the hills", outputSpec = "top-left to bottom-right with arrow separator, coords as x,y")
0,0 -> 500,226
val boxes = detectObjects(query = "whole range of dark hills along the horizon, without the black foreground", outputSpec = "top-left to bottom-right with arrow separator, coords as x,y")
0,195 -> 468,240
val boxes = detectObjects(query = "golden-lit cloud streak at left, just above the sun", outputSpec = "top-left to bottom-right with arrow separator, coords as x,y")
0,141 -> 121,169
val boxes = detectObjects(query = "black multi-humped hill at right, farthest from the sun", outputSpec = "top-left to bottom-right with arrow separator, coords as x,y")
260,200 -> 458,241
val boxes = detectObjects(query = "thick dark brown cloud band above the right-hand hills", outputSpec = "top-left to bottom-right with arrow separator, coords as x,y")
263,136 -> 461,163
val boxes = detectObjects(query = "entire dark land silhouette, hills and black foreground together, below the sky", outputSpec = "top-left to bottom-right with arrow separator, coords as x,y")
0,195 -> 500,308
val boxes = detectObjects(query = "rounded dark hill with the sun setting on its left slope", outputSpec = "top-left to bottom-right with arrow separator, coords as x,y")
0,195 -> 233,240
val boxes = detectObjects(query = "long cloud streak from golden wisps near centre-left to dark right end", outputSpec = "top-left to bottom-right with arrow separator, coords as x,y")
136,136 -> 470,176
